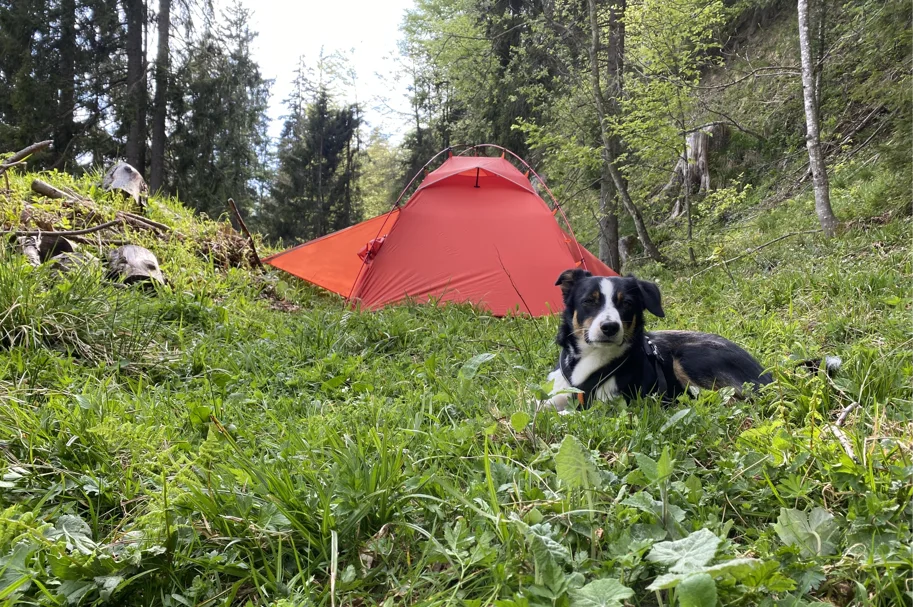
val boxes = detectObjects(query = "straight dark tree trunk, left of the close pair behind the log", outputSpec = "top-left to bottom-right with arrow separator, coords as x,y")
124,0 -> 147,175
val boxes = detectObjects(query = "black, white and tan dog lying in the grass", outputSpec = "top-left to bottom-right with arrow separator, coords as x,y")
548,269 -> 772,411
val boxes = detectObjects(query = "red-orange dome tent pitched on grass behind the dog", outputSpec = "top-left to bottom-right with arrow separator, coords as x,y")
264,154 -> 615,316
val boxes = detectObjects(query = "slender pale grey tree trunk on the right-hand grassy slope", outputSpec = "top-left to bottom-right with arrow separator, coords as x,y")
799,0 -> 839,238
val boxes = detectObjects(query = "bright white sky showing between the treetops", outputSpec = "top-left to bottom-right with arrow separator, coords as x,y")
224,0 -> 413,143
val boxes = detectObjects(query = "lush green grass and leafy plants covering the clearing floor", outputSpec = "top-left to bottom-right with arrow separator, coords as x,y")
0,166 -> 913,607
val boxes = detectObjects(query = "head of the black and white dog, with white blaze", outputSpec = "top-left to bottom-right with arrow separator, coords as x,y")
555,269 -> 665,351
